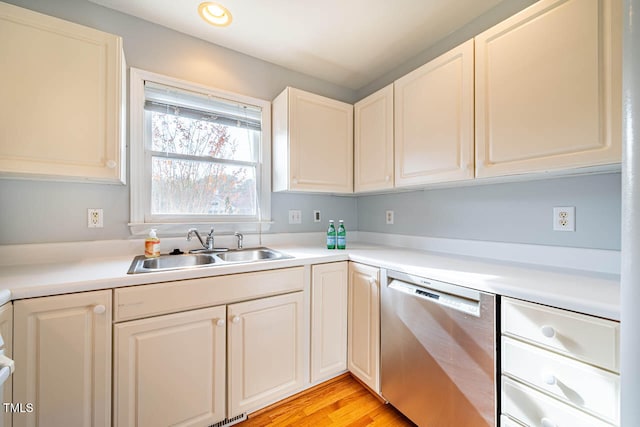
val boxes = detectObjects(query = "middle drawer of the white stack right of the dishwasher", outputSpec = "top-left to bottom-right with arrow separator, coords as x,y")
502,337 -> 620,424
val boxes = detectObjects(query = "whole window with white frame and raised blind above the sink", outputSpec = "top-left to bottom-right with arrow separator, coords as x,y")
131,69 -> 270,234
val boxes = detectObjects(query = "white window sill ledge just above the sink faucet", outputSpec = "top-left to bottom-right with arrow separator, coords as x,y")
128,221 -> 273,237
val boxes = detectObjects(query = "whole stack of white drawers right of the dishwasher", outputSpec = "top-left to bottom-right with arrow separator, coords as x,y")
501,297 -> 620,426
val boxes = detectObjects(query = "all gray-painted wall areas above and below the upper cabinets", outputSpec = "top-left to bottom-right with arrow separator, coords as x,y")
0,0 -> 620,249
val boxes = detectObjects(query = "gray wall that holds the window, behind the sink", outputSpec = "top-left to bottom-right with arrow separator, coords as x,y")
0,0 -> 356,244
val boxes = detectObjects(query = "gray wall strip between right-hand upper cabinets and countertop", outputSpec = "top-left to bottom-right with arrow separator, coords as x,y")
358,173 -> 621,250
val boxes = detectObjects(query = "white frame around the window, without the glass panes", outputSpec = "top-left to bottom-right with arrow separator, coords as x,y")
129,68 -> 272,236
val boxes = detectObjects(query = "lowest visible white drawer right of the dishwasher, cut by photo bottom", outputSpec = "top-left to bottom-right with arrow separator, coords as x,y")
502,376 -> 611,427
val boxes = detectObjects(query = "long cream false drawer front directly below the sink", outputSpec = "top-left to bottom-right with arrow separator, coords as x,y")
114,267 -> 304,322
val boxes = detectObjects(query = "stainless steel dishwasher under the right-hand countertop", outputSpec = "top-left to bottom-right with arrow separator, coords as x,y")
380,270 -> 497,427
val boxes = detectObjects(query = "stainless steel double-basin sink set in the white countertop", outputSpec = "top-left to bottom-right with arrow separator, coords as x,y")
127,247 -> 292,274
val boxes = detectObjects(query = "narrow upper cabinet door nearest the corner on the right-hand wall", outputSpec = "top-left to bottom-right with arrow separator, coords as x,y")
353,84 -> 393,192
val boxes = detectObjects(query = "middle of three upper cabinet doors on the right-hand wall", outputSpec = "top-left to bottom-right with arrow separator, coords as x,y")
394,40 -> 473,187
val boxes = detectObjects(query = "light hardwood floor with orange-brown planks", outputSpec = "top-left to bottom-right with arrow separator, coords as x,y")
237,374 -> 415,427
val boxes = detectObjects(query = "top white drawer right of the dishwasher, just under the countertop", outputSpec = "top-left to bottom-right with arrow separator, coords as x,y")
502,298 -> 620,372
